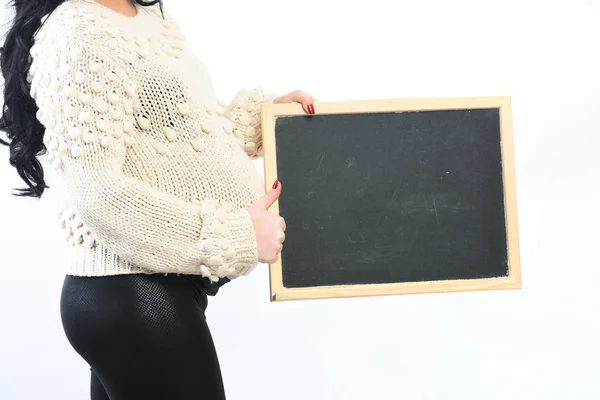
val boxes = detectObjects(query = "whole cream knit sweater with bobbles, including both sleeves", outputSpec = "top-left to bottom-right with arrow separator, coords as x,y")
28,0 -> 274,282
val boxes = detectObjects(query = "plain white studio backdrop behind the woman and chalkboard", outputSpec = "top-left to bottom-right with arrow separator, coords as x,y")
0,0 -> 600,400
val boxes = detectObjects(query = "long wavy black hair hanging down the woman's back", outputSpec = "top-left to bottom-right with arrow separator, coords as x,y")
0,0 -> 162,197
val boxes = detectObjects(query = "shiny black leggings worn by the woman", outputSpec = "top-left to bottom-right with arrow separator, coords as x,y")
60,274 -> 227,400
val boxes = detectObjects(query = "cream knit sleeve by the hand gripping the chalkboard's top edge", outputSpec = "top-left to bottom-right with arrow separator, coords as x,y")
225,86 -> 277,160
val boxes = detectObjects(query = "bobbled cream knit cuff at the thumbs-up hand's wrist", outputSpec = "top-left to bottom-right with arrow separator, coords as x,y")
197,200 -> 258,282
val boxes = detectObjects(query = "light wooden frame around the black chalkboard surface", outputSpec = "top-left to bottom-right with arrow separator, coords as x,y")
262,97 -> 521,301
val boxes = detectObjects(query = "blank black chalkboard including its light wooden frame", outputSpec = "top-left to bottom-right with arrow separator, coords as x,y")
263,98 -> 520,301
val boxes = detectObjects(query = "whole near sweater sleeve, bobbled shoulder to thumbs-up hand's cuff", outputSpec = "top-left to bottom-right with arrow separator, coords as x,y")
29,41 -> 258,281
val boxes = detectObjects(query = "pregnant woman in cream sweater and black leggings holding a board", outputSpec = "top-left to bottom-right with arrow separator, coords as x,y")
0,0 -> 314,400
